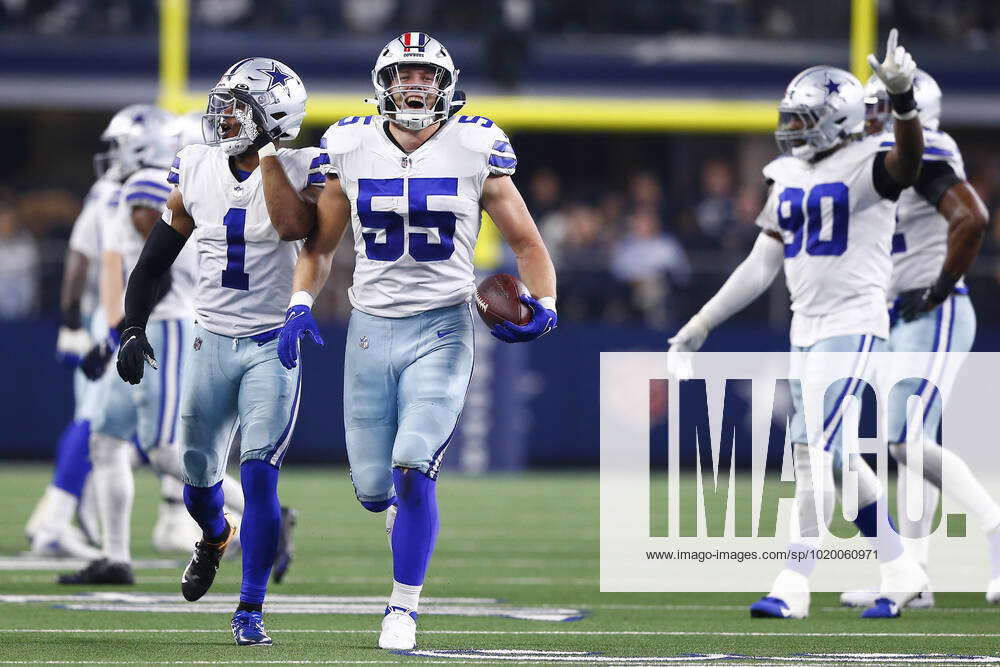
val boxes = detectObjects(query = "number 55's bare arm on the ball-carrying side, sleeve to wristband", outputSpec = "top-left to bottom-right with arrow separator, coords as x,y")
480,176 -> 556,299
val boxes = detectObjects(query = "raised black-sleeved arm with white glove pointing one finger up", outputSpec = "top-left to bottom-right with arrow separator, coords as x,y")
868,28 -> 924,187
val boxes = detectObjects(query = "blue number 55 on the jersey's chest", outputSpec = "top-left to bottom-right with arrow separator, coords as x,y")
358,178 -> 458,262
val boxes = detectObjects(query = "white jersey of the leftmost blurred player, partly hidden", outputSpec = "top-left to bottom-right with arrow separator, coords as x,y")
69,178 -> 122,318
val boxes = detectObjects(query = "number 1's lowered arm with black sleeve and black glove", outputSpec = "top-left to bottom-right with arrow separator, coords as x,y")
118,188 -> 194,384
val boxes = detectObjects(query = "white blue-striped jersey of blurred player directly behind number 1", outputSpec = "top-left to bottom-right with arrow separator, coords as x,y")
108,167 -> 196,322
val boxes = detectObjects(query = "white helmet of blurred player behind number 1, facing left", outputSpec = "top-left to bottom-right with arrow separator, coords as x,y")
94,104 -> 175,180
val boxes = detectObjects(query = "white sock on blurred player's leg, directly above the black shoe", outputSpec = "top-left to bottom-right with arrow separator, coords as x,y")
90,433 -> 135,563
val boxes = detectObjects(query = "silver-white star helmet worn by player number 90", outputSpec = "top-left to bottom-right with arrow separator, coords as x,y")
774,65 -> 865,160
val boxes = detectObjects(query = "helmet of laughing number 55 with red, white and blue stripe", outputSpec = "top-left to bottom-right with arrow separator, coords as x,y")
367,32 -> 459,130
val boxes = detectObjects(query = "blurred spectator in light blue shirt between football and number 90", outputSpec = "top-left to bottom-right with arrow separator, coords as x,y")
611,208 -> 691,327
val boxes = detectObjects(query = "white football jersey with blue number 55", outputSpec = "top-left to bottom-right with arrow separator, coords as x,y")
319,116 -> 517,317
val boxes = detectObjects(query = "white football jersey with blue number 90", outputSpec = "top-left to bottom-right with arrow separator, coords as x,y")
757,137 -> 896,347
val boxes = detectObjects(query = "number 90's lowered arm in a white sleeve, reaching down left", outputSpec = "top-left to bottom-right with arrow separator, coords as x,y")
668,230 -> 785,366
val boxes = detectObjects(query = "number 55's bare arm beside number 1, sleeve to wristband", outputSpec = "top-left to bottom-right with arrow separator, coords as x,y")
292,178 -> 351,297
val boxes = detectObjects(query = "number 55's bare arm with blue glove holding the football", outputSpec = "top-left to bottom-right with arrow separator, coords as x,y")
480,174 -> 558,343
